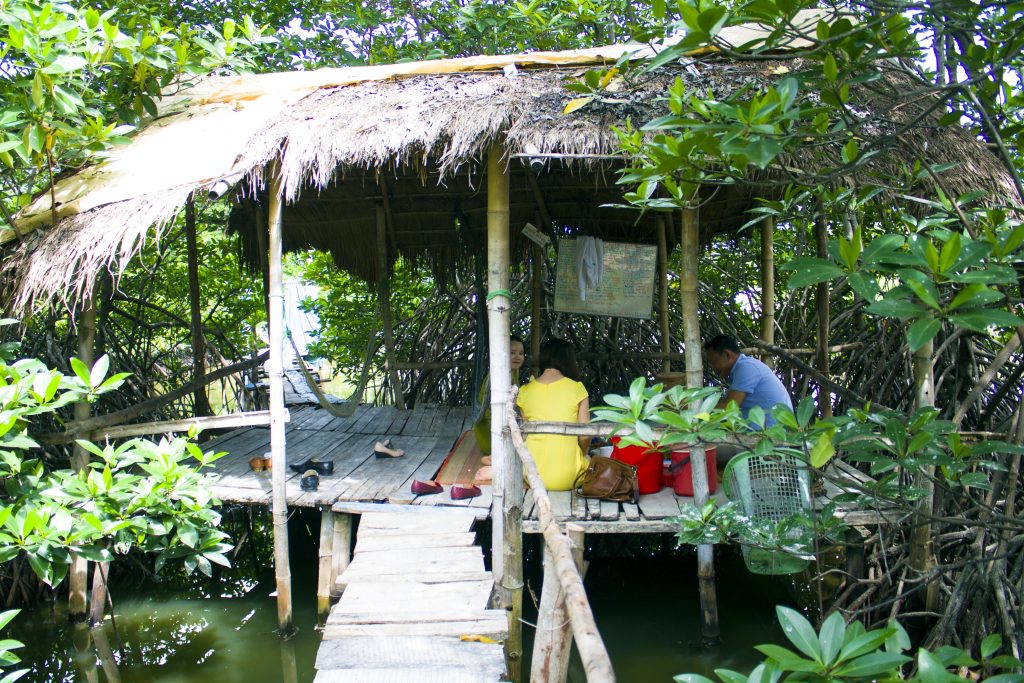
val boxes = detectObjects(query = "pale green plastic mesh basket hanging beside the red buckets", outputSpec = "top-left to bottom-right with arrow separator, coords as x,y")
724,454 -> 811,574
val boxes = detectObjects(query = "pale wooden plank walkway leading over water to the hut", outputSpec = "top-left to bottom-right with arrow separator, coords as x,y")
314,507 -> 508,683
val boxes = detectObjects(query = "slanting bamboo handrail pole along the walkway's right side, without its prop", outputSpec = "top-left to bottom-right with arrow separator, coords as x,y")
505,386 -> 615,683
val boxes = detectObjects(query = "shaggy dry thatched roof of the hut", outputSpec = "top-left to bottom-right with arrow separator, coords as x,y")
0,21 -> 1014,307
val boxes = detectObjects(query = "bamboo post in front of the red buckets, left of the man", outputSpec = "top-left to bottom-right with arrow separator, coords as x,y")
680,201 -> 720,645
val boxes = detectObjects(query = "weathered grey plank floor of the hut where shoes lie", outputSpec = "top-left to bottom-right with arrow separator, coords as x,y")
203,405 -> 886,533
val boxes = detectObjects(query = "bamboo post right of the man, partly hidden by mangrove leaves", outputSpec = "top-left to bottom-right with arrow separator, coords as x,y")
908,341 -> 938,610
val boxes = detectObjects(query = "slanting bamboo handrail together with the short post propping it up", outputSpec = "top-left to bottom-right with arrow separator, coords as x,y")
506,386 -> 615,683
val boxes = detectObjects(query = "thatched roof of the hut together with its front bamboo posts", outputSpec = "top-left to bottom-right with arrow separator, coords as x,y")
6,30 -> 1014,651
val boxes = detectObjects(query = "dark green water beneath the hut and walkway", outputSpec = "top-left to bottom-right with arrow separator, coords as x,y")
4,514 -> 794,683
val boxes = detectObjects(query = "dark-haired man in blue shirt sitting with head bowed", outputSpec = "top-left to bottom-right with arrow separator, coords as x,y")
705,335 -> 793,465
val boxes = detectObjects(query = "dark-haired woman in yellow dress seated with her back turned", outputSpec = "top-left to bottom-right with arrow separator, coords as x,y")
516,339 -> 590,490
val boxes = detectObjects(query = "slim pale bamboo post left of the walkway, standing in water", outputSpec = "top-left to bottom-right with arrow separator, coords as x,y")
267,159 -> 294,638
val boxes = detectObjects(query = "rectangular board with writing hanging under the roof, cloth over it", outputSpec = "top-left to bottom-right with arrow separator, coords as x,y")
555,238 -> 657,318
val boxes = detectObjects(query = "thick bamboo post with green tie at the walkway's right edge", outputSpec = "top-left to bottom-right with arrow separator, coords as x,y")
486,143 -> 523,681
